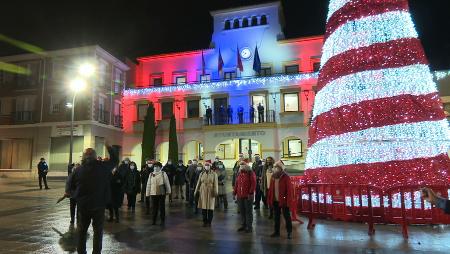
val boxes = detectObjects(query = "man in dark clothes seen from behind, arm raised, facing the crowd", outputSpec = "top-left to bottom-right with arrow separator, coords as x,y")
66,145 -> 119,253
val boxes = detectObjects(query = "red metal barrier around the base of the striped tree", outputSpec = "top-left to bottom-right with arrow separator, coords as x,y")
291,176 -> 450,238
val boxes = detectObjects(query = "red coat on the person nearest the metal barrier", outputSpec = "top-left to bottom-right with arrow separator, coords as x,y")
267,172 -> 294,207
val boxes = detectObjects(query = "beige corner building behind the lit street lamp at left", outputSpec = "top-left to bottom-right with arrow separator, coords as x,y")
0,46 -> 129,172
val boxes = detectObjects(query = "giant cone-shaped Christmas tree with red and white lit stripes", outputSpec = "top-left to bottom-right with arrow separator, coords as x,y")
306,0 -> 450,188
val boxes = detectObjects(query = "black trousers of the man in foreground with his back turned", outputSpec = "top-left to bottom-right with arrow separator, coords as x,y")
77,208 -> 105,254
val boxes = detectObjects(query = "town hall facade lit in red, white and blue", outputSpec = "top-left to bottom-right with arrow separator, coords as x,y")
122,2 -> 323,170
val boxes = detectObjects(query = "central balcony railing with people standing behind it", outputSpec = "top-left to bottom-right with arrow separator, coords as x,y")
203,110 -> 276,125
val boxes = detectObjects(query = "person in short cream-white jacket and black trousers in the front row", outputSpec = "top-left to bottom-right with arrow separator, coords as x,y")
145,162 -> 172,226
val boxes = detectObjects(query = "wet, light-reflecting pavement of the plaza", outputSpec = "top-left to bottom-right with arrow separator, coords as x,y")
0,178 -> 450,254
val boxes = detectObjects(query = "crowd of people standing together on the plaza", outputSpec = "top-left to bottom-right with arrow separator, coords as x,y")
59,144 -> 293,253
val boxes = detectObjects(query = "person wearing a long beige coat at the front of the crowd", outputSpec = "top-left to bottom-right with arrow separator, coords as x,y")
195,161 -> 219,227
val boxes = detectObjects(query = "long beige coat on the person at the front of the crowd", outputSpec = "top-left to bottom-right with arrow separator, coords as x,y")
195,170 -> 219,210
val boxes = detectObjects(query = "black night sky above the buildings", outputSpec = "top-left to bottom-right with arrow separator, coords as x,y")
0,0 -> 450,69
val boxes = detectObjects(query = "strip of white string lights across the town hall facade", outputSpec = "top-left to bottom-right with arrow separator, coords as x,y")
123,73 -> 318,97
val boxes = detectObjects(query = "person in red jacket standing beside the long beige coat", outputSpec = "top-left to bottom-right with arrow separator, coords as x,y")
233,162 -> 256,233
